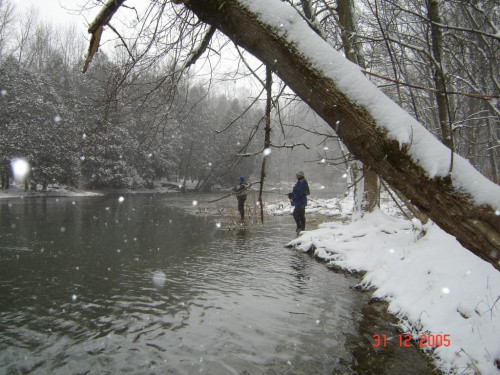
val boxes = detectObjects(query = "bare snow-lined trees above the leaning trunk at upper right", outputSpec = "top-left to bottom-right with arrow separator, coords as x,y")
358,0 -> 500,181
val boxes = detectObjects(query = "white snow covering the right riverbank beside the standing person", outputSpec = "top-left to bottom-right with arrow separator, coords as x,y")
268,197 -> 500,375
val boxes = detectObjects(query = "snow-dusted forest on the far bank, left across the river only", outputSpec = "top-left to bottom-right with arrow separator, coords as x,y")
0,1 -> 266,189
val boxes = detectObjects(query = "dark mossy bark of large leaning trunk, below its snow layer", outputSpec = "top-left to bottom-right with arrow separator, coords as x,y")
186,0 -> 500,270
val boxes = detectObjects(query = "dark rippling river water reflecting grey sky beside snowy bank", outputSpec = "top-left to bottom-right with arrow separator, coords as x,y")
0,194 -> 432,374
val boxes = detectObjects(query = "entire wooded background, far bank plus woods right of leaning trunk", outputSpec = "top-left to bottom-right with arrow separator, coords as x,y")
0,0 -> 500,194
